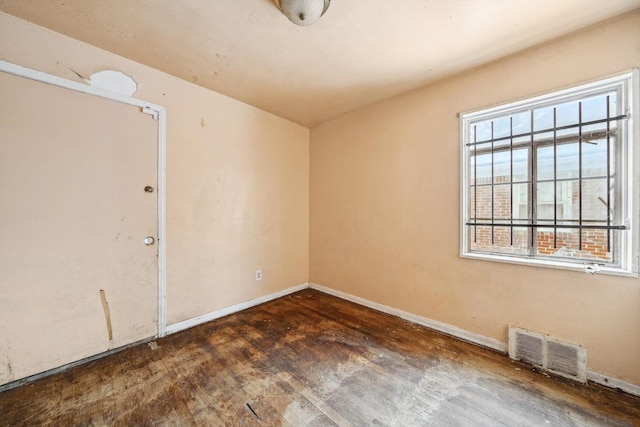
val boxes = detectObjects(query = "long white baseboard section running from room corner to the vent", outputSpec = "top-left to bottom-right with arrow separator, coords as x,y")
309,283 -> 507,353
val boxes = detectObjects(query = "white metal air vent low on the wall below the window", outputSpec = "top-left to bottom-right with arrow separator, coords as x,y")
509,326 -> 587,383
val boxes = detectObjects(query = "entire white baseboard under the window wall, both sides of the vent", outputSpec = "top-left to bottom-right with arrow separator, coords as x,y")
309,283 -> 640,396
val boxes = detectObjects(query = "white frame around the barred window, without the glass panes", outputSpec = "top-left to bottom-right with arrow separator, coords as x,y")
459,68 -> 640,277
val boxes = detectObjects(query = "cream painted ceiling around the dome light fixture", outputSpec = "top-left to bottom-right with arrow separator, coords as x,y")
0,0 -> 640,127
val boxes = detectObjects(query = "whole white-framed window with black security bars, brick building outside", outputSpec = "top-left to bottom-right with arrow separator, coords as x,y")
461,70 -> 640,276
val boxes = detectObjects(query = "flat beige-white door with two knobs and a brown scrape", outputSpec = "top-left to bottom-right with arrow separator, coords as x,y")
0,72 -> 158,384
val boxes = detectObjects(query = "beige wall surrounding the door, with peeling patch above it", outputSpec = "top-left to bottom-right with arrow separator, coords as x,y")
0,13 -> 309,338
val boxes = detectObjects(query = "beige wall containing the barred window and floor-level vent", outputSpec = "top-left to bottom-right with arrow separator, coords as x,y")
310,12 -> 640,384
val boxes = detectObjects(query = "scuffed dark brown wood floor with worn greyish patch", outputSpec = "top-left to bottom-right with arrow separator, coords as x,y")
0,290 -> 640,426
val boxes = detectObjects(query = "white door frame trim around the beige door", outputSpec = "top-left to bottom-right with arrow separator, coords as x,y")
0,60 -> 167,337
